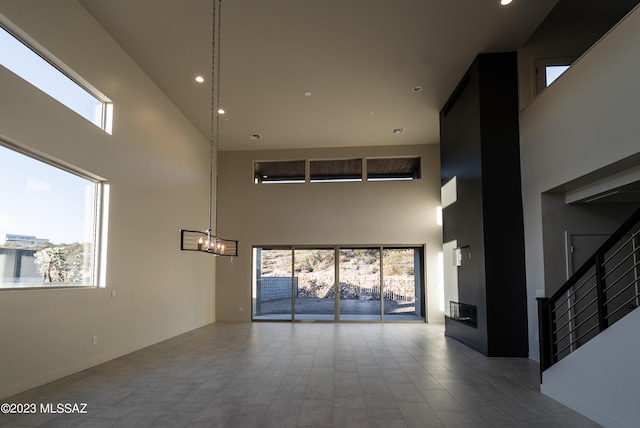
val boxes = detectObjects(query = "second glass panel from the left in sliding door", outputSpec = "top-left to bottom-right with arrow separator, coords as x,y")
294,248 -> 336,321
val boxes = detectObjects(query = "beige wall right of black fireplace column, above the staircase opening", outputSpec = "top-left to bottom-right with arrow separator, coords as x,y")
520,8 -> 640,359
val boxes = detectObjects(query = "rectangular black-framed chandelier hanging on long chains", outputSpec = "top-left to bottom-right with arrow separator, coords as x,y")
180,0 -> 238,257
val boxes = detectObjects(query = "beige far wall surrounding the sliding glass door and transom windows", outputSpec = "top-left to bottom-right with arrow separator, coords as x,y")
216,145 -> 443,322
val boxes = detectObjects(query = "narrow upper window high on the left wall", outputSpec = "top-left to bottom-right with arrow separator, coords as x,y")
0,27 -> 113,133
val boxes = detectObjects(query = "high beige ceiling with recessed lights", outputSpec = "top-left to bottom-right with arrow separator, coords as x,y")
80,0 -> 558,150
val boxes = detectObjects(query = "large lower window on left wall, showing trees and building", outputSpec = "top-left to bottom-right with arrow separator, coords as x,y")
0,145 -> 103,289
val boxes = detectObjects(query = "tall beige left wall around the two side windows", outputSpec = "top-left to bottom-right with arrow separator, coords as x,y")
0,0 -> 214,397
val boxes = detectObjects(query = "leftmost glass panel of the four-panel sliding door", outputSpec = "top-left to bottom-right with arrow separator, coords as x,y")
252,248 -> 295,320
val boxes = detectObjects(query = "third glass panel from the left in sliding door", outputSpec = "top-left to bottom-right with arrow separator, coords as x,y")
339,248 -> 382,321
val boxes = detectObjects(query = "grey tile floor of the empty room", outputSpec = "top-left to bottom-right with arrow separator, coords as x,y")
0,323 -> 598,428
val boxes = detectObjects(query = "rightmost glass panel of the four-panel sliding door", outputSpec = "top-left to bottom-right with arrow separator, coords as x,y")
382,248 -> 424,321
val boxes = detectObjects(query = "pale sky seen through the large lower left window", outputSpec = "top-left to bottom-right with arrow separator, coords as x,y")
0,146 -> 96,244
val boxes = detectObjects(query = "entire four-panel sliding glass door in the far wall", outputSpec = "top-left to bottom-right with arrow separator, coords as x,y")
253,247 -> 425,321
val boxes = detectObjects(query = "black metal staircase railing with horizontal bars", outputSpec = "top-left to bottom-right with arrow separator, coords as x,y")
537,208 -> 640,371
